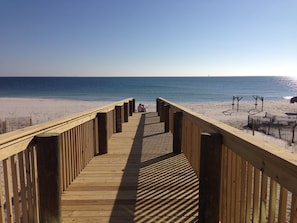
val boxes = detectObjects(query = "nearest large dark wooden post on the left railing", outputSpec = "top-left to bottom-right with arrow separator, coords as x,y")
36,133 -> 62,223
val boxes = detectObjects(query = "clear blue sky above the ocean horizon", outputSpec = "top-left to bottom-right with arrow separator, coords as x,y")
0,0 -> 297,76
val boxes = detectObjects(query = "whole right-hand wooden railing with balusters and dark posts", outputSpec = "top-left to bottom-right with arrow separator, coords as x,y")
157,98 -> 297,223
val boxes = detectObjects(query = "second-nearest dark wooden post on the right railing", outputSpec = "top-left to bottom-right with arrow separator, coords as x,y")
173,112 -> 183,154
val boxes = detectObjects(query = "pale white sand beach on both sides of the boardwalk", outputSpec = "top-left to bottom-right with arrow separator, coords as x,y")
0,98 -> 297,151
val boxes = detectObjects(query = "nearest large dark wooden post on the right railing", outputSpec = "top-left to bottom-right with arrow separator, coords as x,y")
198,133 -> 222,223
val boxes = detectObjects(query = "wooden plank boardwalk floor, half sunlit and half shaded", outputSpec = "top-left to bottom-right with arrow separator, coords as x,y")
62,113 -> 199,223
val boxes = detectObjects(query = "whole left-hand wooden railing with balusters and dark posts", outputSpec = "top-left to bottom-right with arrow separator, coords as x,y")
0,98 -> 135,223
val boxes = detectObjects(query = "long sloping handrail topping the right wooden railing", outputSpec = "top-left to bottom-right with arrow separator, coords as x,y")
158,97 -> 297,194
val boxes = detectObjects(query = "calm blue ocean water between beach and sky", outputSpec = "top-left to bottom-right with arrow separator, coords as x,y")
0,76 -> 297,102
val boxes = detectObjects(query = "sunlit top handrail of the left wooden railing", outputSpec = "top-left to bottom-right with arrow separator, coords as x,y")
0,98 -> 132,160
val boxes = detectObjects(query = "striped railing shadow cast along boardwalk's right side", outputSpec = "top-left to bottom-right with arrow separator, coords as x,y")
110,113 -> 199,223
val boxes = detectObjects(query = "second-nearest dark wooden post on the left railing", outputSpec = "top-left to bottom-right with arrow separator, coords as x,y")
97,112 -> 108,154
